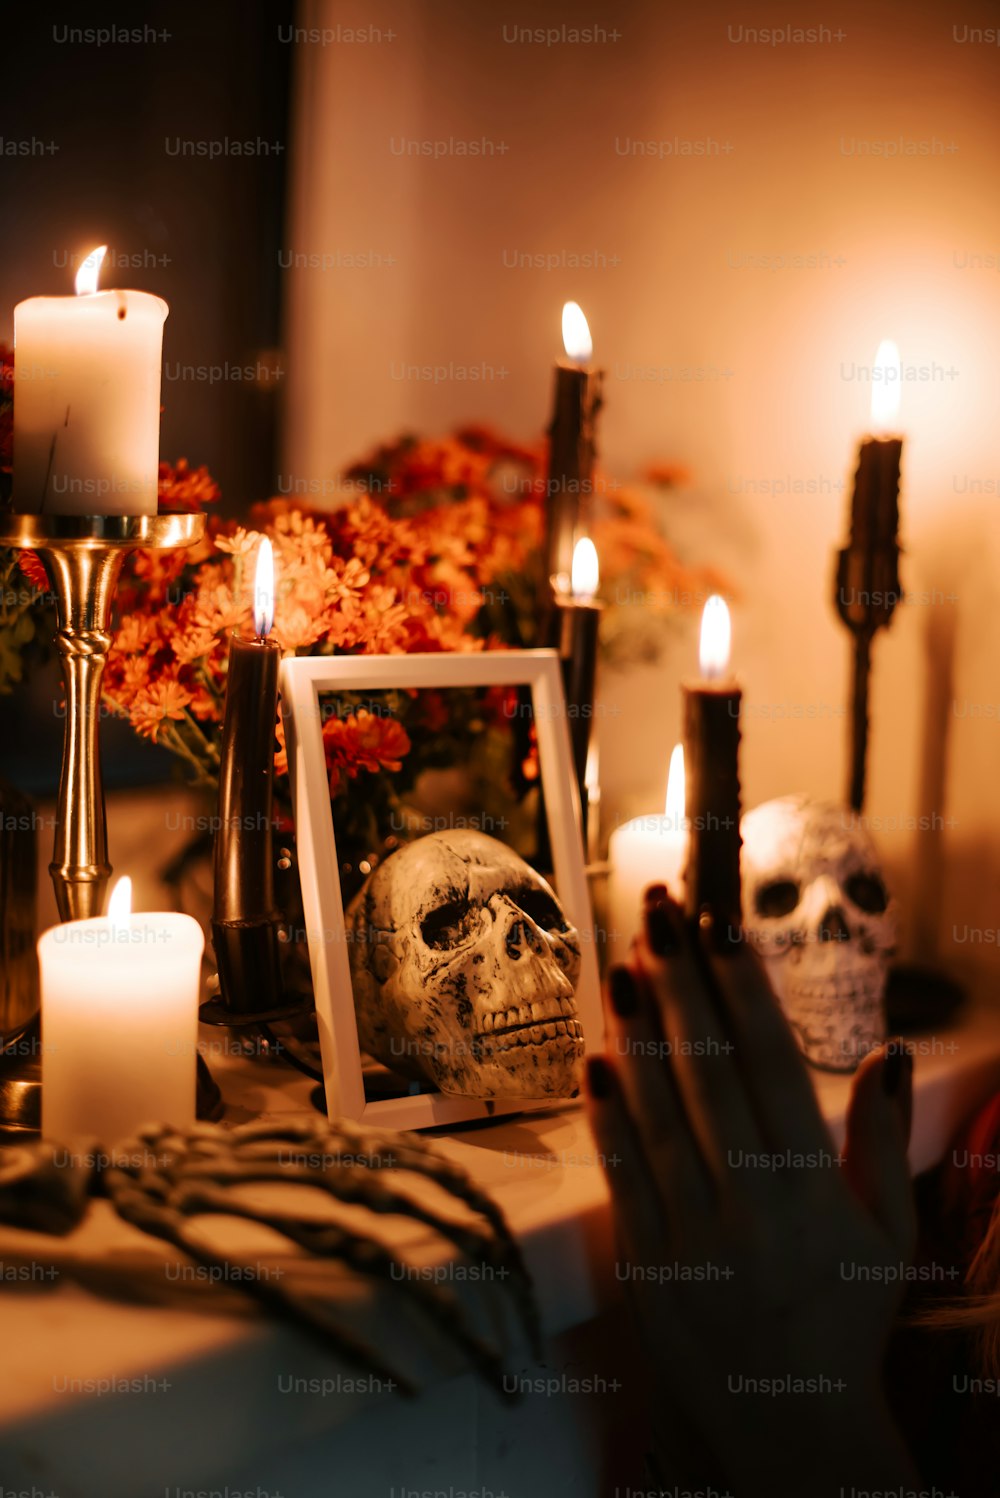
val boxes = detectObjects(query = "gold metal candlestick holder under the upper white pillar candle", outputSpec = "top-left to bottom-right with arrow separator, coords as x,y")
0,515 -> 205,921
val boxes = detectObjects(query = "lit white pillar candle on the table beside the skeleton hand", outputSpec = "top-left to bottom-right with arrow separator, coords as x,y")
37,879 -> 205,1146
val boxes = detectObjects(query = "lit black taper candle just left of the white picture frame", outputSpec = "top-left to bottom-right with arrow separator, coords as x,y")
213,539 -> 281,1013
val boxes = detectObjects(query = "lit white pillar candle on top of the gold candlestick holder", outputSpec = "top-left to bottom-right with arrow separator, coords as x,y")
13,247 -> 169,515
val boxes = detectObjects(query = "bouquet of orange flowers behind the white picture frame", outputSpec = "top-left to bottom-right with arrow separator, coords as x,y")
0,404 -> 719,874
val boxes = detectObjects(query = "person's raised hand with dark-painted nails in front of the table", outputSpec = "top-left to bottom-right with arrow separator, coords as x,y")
587,888 -> 915,1498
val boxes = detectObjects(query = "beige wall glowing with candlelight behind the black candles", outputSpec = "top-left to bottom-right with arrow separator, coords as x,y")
284,0 -> 1000,966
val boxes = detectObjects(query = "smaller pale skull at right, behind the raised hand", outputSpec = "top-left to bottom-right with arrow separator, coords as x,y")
741,795 -> 897,1071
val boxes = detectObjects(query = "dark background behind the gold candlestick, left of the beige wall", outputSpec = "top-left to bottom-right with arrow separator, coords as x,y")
0,0 -> 293,792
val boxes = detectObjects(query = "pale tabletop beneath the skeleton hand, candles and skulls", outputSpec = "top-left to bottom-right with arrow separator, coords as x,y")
0,1001 -> 1000,1438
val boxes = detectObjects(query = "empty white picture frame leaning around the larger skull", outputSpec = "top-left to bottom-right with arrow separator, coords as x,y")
280,650 -> 603,1129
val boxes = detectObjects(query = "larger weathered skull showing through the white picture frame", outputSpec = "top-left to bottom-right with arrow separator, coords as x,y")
347,830 -> 584,1100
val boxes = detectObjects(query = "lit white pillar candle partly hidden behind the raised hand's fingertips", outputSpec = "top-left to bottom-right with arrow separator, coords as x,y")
608,745 -> 687,962
